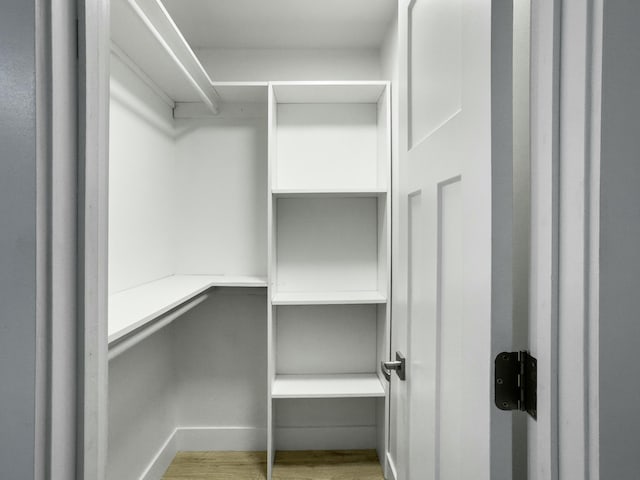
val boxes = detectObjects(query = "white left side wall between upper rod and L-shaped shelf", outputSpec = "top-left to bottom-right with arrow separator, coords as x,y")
109,51 -> 177,293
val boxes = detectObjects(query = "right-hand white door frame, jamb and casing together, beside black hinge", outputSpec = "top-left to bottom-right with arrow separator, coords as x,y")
528,0 -> 603,480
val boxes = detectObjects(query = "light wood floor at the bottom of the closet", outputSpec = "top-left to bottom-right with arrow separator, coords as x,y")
162,450 -> 384,480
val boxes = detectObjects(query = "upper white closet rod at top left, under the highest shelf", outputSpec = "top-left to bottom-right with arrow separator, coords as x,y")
126,0 -> 220,114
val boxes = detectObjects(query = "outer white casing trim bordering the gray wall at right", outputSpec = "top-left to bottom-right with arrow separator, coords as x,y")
558,0 -> 603,480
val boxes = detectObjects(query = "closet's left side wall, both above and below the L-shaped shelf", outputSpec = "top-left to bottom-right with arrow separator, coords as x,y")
107,51 -> 176,480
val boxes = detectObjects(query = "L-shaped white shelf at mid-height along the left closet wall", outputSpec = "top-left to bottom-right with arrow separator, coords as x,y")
108,275 -> 267,344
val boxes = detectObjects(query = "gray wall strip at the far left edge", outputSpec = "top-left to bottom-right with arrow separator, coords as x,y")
0,0 -> 38,479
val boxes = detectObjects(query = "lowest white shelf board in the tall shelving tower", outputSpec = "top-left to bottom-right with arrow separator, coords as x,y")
271,373 -> 385,398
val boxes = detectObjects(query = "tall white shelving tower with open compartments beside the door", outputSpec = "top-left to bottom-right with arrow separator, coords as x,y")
268,82 -> 391,475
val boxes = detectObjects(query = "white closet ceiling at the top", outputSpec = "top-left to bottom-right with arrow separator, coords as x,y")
163,0 -> 397,48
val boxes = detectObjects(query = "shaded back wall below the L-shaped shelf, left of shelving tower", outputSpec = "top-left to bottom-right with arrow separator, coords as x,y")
173,288 -> 267,436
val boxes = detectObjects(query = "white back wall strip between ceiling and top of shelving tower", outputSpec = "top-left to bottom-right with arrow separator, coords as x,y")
196,48 -> 381,81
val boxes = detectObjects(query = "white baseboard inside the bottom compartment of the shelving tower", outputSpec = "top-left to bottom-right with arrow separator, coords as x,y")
275,425 -> 377,450
